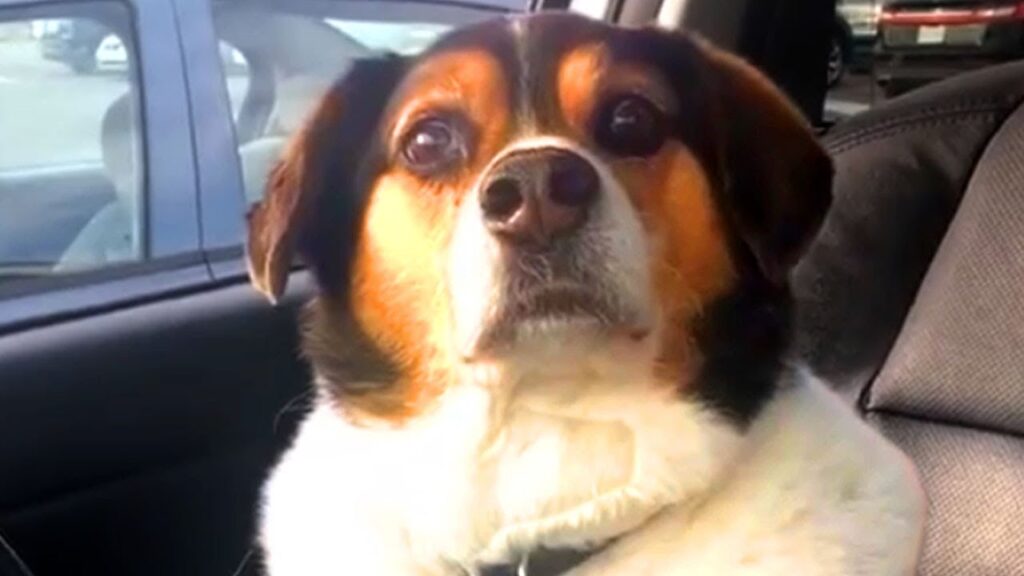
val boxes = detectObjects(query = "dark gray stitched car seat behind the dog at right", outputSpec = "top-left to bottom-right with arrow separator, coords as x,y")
793,63 -> 1024,576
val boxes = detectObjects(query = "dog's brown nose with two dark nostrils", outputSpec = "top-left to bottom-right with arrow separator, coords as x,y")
480,149 -> 601,247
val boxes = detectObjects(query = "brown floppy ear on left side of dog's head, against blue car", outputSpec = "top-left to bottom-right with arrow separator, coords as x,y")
246,56 -> 407,302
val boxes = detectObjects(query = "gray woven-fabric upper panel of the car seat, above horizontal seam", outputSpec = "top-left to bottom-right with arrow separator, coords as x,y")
868,96 -> 1024,435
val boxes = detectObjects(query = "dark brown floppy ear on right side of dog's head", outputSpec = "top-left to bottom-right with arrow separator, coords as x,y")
703,46 -> 833,285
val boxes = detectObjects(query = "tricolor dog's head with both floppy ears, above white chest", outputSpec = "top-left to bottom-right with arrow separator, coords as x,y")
249,14 -> 831,424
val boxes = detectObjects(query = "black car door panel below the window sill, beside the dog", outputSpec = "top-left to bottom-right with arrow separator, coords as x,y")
0,276 -> 309,575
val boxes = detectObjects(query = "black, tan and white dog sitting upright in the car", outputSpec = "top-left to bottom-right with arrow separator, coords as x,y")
247,13 -> 926,576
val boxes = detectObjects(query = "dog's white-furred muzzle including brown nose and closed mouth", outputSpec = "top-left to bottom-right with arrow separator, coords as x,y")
449,138 -> 646,358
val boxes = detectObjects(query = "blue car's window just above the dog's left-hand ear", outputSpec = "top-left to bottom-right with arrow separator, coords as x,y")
208,0 -> 512,203
